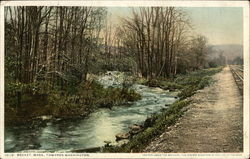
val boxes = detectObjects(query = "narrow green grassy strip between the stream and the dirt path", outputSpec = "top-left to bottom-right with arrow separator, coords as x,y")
103,67 -> 223,152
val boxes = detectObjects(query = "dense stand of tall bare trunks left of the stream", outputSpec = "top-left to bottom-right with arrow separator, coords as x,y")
5,7 -> 105,87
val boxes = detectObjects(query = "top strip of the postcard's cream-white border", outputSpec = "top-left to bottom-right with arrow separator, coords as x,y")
2,0 -> 249,7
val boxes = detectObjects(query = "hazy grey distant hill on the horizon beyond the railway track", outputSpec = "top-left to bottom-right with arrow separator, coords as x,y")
209,44 -> 243,60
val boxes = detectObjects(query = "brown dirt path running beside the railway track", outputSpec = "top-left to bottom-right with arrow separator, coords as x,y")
144,67 -> 243,152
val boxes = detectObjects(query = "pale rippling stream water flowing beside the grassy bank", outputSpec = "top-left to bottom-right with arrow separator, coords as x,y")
4,71 -> 176,152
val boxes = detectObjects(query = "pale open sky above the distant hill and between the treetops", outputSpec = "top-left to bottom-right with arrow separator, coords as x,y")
108,7 -> 243,45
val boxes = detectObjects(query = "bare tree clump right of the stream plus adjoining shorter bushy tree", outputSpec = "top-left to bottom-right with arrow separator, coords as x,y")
121,7 -> 207,78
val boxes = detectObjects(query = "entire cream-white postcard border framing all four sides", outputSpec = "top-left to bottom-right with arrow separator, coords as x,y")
0,1 -> 250,159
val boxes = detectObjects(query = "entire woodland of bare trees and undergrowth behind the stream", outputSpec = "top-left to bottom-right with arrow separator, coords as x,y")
4,6 -> 226,123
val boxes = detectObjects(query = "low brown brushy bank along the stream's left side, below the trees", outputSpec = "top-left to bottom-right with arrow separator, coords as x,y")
5,72 -> 141,128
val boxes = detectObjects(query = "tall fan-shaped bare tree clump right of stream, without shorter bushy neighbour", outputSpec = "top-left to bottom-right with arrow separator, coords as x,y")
119,7 -> 189,78
